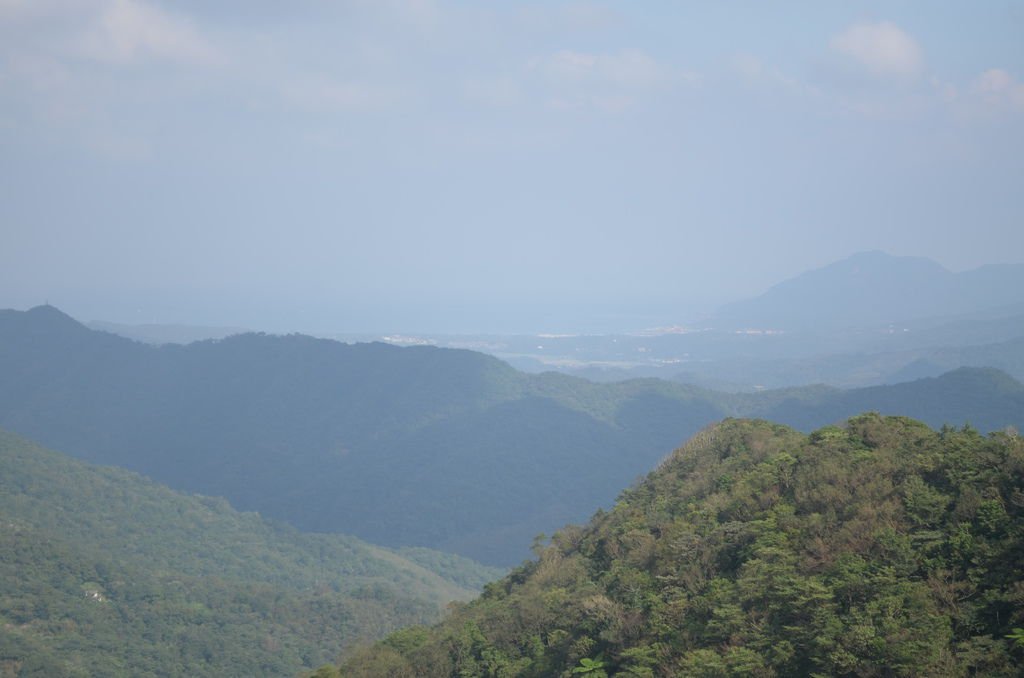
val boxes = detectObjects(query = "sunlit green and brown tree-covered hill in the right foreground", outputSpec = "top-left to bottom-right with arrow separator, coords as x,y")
337,414 -> 1024,678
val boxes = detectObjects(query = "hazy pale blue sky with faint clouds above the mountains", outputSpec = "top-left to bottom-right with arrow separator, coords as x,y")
0,0 -> 1024,332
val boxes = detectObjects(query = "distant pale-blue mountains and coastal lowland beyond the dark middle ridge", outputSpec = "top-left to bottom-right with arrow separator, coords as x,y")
83,252 -> 1024,390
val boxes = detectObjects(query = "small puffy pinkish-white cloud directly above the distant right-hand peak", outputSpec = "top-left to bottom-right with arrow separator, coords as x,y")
829,22 -> 924,77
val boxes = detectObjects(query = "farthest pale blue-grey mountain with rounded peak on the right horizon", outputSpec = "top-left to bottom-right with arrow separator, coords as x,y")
716,251 -> 1024,330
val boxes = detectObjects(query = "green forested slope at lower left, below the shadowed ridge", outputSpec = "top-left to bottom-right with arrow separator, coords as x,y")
0,430 -> 494,676
